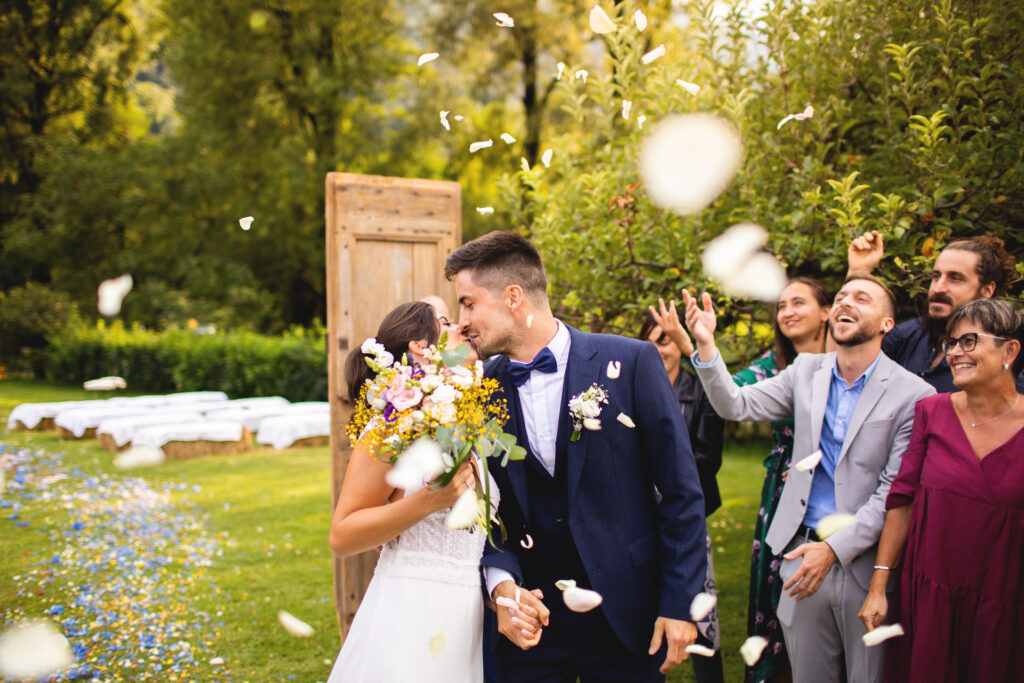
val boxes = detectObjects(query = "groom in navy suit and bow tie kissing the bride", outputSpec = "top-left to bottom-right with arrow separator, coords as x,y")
444,232 -> 706,683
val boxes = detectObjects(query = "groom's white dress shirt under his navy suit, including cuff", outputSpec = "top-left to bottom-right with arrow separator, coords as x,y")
486,321 -> 570,596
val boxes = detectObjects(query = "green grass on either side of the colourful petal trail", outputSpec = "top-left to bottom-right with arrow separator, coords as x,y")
0,380 -> 767,683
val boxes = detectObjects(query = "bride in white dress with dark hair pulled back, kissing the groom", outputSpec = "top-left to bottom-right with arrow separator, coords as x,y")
328,302 -> 489,683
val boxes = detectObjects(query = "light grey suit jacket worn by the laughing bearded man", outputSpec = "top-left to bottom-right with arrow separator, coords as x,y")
696,353 -> 935,590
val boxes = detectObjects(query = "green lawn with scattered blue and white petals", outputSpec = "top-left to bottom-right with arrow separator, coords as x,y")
0,380 -> 767,683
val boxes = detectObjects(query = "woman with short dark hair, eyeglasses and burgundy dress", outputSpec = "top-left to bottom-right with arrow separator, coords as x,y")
860,299 -> 1024,683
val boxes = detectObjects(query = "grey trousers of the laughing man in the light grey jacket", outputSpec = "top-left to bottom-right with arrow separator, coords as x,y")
778,536 -> 885,683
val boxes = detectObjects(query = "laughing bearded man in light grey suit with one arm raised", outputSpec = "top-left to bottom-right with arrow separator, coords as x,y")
683,274 -> 935,683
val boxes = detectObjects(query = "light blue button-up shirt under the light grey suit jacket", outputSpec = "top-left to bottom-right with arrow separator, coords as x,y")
804,353 -> 882,528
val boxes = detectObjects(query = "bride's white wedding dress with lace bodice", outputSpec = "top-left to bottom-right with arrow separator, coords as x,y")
328,480 -> 498,683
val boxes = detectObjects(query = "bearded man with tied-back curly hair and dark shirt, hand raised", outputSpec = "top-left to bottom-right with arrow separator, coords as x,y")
848,230 -> 1024,393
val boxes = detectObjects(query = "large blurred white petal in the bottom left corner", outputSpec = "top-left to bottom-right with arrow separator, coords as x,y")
0,622 -> 75,680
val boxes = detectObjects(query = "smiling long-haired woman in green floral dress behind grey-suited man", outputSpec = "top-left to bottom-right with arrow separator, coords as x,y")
732,278 -> 830,683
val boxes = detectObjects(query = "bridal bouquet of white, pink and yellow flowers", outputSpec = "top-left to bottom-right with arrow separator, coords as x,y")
345,333 -> 526,538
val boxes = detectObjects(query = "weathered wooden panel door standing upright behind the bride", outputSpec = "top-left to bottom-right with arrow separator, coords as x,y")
327,173 -> 462,640
